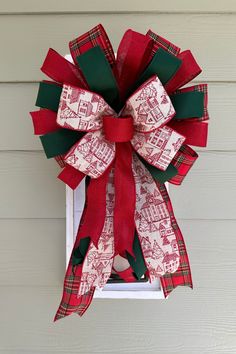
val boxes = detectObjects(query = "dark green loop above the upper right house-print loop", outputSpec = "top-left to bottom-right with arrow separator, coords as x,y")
136,48 -> 182,87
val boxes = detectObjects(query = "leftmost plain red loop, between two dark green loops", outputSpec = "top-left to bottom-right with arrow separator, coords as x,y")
30,109 -> 60,135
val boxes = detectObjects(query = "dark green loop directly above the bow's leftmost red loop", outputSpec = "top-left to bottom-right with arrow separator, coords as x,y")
35,82 -> 62,112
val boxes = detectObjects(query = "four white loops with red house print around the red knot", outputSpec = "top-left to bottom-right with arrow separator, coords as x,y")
57,76 -> 185,178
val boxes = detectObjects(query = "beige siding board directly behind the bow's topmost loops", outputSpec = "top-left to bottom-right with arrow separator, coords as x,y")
0,14 -> 236,81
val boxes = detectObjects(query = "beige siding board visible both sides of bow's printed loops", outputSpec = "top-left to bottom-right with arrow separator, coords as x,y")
0,83 -> 232,151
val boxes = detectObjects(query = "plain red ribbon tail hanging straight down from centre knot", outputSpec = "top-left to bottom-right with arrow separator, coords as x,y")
114,143 -> 136,255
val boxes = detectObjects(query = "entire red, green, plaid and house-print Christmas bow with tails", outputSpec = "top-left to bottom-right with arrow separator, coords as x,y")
31,25 -> 209,320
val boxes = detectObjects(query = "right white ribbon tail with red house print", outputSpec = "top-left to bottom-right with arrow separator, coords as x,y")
132,156 -> 180,281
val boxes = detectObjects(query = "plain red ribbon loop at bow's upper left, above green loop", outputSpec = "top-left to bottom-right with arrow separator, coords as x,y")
41,48 -> 88,88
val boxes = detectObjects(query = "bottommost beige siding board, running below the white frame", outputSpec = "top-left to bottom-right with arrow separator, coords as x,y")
0,284 -> 236,354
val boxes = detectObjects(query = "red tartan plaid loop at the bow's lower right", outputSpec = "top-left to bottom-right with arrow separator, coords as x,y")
168,145 -> 198,185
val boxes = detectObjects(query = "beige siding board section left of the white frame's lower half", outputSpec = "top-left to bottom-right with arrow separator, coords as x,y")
0,219 -> 66,286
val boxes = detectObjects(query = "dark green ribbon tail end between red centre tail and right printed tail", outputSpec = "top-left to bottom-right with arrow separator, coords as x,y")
126,234 -> 147,279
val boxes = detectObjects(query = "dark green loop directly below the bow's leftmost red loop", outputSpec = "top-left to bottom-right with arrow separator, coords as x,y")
40,129 -> 84,159
